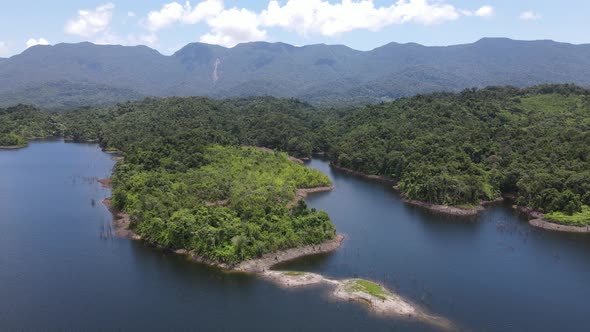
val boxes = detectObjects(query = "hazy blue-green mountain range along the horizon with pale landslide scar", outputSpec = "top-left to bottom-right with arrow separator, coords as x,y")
0,38 -> 590,109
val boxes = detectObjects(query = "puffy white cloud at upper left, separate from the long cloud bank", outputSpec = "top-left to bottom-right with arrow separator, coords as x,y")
65,3 -> 115,37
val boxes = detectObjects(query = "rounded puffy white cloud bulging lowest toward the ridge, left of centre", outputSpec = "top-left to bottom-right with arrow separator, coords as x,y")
201,8 -> 266,47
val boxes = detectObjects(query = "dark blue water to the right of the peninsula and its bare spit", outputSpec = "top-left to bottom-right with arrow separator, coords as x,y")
294,160 -> 590,332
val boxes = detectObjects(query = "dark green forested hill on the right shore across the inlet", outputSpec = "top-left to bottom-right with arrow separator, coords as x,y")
326,85 -> 590,223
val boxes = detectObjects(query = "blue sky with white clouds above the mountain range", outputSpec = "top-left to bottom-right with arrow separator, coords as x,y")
0,0 -> 590,57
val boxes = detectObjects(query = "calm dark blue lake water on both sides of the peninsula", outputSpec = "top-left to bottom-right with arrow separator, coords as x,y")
0,141 -> 590,331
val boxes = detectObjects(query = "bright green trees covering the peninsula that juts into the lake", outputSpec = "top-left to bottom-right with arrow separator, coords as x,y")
113,146 -> 335,263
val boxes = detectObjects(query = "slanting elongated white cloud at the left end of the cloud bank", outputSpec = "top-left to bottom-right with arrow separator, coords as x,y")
144,0 -> 224,31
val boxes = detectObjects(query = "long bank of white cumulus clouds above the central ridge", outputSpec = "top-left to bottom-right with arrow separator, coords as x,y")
144,0 -> 494,46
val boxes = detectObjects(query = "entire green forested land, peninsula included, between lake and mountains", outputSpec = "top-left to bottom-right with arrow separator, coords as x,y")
0,85 -> 590,253
